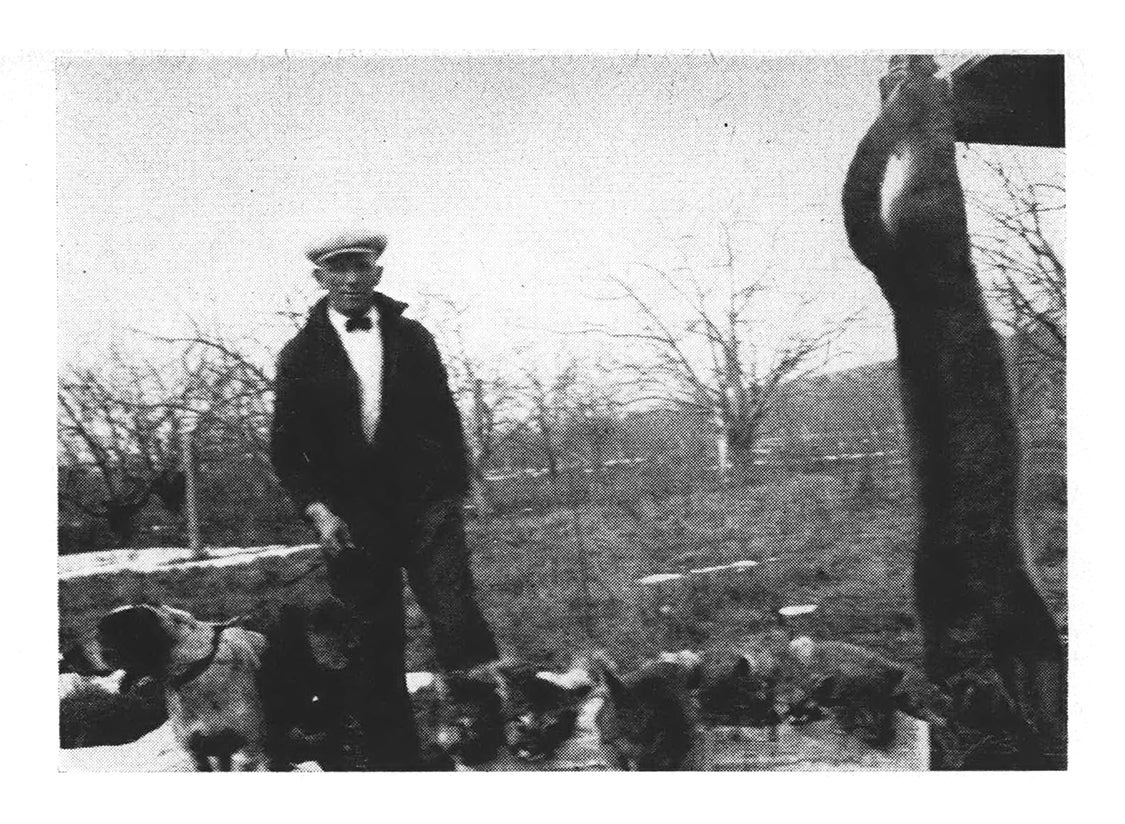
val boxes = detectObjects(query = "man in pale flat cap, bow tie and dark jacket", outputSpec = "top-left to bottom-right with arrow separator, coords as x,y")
270,233 -> 496,770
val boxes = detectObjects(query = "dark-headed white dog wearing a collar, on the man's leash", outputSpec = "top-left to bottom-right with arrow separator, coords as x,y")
65,603 -> 267,771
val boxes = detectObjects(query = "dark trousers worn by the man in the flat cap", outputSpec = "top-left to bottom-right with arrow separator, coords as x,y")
330,501 -> 497,770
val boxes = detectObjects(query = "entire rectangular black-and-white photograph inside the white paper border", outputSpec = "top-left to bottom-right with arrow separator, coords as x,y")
48,47 -> 1078,774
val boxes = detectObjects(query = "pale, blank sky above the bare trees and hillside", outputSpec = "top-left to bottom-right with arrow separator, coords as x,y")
57,54 -> 1063,380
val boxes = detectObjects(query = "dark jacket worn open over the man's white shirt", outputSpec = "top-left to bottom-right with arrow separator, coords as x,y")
270,293 -> 469,538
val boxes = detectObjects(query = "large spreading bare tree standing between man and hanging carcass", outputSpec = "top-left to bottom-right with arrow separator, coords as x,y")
601,224 -> 851,486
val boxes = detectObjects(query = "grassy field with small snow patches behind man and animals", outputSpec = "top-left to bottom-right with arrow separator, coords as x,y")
59,467 -> 1067,669
